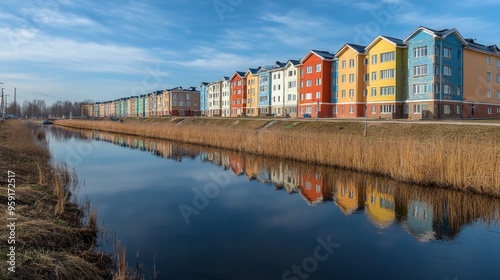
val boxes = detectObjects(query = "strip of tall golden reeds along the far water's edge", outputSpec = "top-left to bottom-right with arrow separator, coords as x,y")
57,120 -> 500,196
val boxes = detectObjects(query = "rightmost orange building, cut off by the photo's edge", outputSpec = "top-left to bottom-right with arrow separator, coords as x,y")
462,39 -> 500,118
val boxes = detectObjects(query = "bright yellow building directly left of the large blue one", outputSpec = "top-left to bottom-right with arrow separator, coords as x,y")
366,36 -> 408,119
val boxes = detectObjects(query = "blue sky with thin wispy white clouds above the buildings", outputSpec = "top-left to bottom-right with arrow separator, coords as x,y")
0,0 -> 500,104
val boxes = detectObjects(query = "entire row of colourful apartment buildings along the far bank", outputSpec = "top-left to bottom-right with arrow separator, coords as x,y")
84,27 -> 500,119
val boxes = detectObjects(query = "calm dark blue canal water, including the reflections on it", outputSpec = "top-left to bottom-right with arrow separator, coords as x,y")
38,127 -> 500,280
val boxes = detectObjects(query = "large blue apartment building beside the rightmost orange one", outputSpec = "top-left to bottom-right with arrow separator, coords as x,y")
404,27 -> 467,119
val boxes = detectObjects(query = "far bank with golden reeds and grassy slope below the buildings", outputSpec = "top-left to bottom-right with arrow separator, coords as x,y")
57,118 -> 500,196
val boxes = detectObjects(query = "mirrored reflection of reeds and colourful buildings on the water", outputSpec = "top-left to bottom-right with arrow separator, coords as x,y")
47,127 -> 500,242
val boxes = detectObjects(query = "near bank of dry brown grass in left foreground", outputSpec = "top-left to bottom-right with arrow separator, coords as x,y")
0,120 -> 116,279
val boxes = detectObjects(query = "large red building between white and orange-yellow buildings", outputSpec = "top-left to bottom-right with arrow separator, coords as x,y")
298,50 -> 335,118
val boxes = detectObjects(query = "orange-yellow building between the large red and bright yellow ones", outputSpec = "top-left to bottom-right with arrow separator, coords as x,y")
334,44 -> 368,118
